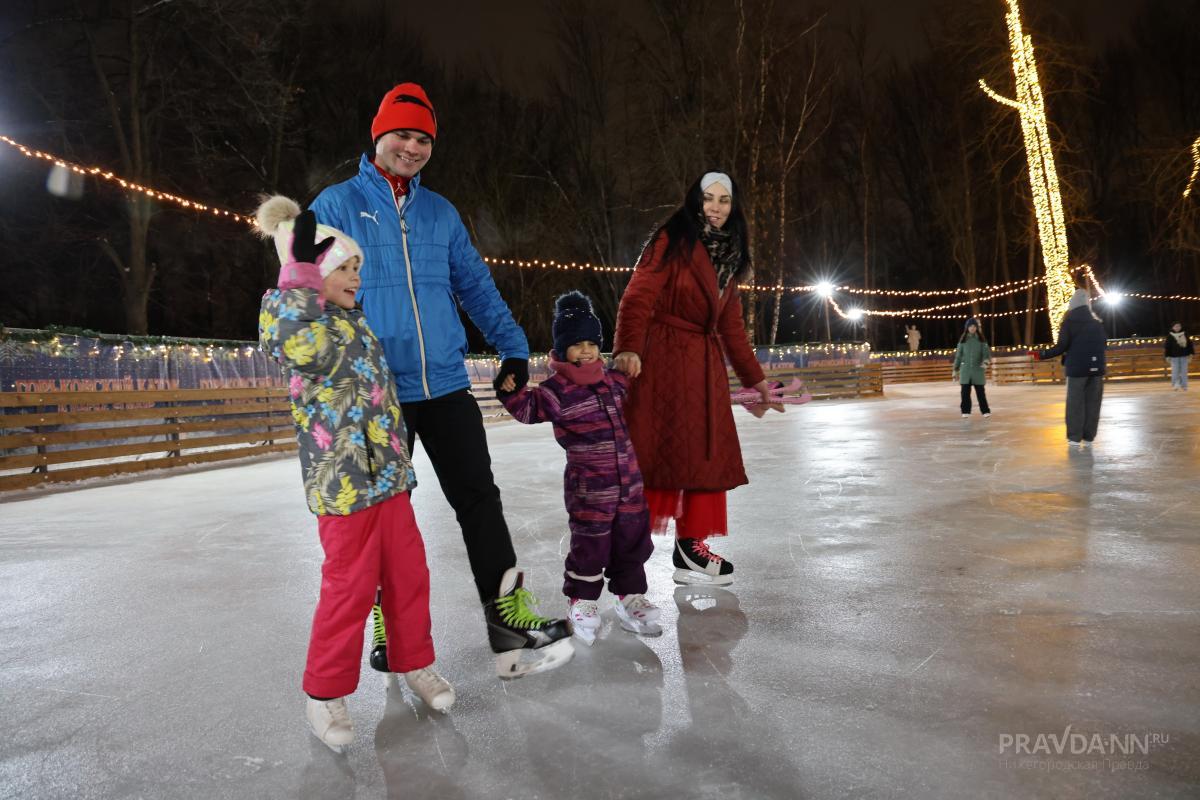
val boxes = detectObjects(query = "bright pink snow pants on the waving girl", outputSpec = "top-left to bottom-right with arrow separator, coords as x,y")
304,493 -> 433,697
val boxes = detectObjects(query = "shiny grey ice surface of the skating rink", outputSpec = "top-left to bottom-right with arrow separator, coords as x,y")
0,383 -> 1200,800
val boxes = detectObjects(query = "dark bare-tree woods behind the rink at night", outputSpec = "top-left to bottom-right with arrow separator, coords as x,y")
0,0 -> 1200,349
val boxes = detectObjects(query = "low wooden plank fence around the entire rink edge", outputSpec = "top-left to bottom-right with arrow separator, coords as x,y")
16,347 -> 1180,492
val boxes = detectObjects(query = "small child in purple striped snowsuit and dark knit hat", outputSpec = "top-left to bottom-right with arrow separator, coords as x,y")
497,291 -> 662,644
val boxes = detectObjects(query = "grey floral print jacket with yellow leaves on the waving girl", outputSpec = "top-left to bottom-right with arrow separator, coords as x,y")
258,287 -> 416,516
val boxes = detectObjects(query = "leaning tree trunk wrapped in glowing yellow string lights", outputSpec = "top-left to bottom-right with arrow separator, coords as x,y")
979,0 -> 1075,342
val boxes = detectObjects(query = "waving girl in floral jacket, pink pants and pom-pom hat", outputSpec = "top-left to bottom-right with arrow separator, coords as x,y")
257,196 -> 455,751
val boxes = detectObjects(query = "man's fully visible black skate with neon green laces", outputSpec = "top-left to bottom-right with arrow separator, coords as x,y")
484,567 -> 575,680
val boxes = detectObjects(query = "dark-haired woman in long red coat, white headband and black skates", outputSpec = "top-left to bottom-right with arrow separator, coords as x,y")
612,173 -> 769,584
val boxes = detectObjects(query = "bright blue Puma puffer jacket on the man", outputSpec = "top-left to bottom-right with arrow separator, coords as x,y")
311,156 -> 529,403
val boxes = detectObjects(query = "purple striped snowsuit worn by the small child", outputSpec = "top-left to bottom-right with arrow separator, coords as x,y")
500,360 -> 654,600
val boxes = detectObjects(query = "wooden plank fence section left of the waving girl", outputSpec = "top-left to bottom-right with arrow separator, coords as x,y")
0,387 -> 296,492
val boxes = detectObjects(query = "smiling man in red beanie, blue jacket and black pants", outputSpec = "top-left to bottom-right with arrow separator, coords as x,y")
312,83 -> 574,678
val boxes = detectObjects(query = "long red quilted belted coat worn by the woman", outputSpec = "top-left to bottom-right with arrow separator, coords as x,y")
612,233 -> 763,492
